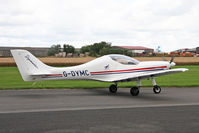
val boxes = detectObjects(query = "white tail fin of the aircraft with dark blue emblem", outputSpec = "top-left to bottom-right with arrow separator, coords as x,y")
11,49 -> 51,81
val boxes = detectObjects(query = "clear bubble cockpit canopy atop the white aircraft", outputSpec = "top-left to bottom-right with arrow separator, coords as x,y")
109,55 -> 139,65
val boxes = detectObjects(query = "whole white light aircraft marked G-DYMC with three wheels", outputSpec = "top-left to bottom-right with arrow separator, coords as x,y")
11,50 -> 188,96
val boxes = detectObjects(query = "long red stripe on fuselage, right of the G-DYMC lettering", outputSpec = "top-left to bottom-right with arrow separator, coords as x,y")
91,66 -> 167,74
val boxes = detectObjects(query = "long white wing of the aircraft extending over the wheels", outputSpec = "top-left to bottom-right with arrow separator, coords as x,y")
104,68 -> 188,82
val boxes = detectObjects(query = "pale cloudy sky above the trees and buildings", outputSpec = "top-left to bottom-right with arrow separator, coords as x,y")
0,0 -> 199,52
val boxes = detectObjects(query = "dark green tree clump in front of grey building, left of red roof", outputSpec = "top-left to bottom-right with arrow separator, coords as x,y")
48,41 -> 132,57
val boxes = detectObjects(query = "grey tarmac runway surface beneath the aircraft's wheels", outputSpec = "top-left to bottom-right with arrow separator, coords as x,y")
0,88 -> 199,133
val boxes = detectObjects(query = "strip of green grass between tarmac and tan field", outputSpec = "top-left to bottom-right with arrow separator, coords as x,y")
0,65 -> 199,89
